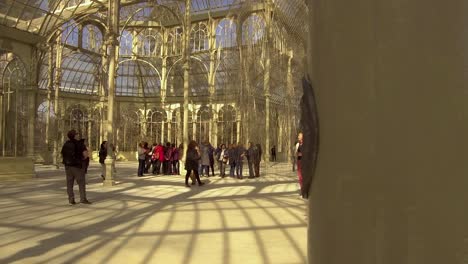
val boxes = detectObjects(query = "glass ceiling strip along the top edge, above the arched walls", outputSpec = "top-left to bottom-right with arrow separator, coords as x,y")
0,0 -> 307,36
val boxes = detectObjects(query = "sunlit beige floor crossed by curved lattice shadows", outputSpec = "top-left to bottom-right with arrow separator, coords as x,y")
0,162 -> 307,264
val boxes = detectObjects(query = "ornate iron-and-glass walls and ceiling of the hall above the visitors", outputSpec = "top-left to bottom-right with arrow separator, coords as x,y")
0,0 -> 308,164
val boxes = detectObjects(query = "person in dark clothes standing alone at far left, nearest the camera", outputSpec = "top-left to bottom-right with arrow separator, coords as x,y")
61,129 -> 91,205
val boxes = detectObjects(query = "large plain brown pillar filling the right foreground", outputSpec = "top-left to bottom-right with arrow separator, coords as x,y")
308,0 -> 468,264
